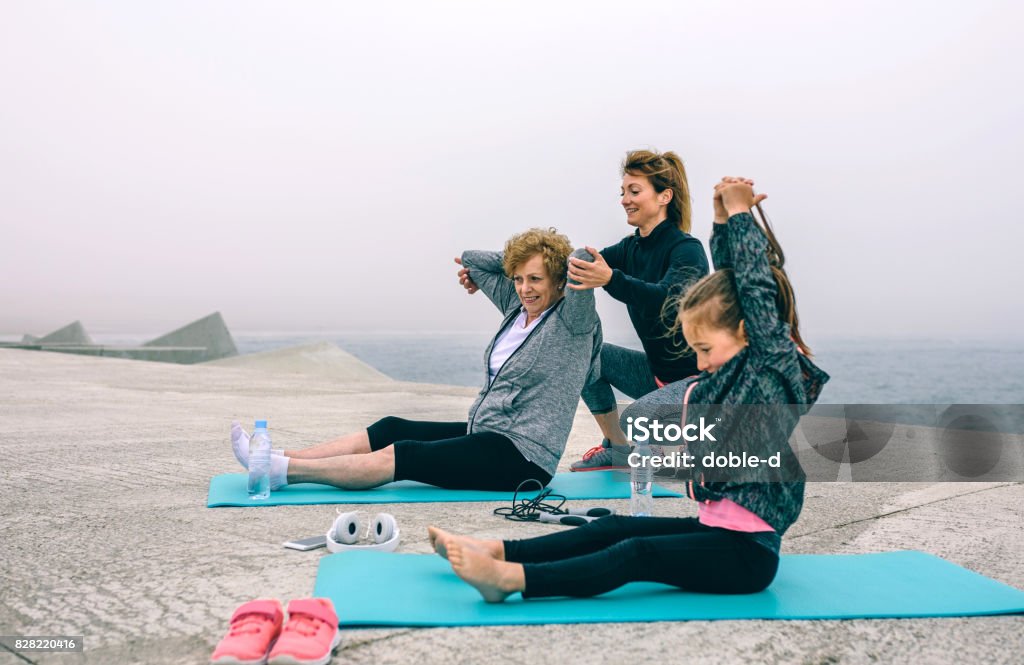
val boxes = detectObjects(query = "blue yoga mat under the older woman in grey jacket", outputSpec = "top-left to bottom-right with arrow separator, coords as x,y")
206,471 -> 683,508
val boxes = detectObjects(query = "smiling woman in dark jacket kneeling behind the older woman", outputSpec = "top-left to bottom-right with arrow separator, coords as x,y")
569,151 -> 708,471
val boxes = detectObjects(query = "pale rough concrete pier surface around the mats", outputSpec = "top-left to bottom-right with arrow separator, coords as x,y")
0,349 -> 1024,665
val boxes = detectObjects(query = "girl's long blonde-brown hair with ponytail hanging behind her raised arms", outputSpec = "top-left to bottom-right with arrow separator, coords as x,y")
673,205 -> 811,358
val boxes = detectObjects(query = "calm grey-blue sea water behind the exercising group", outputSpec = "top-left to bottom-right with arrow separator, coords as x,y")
72,331 -> 1024,404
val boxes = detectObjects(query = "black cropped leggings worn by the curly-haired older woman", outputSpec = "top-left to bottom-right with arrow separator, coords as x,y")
367,416 -> 551,492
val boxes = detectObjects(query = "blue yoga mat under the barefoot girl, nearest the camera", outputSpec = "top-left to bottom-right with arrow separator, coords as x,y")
313,551 -> 1024,627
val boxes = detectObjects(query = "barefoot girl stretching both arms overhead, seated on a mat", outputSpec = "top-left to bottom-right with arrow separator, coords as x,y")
430,178 -> 828,602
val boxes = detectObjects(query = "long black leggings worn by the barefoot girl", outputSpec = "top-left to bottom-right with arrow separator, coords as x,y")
505,515 -> 778,597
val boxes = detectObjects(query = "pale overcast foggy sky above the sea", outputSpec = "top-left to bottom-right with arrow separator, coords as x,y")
0,0 -> 1024,342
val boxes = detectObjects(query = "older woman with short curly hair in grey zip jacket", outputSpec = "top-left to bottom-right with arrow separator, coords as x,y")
231,228 -> 601,491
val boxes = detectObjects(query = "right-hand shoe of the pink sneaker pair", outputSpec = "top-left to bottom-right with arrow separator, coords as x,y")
267,598 -> 341,665
